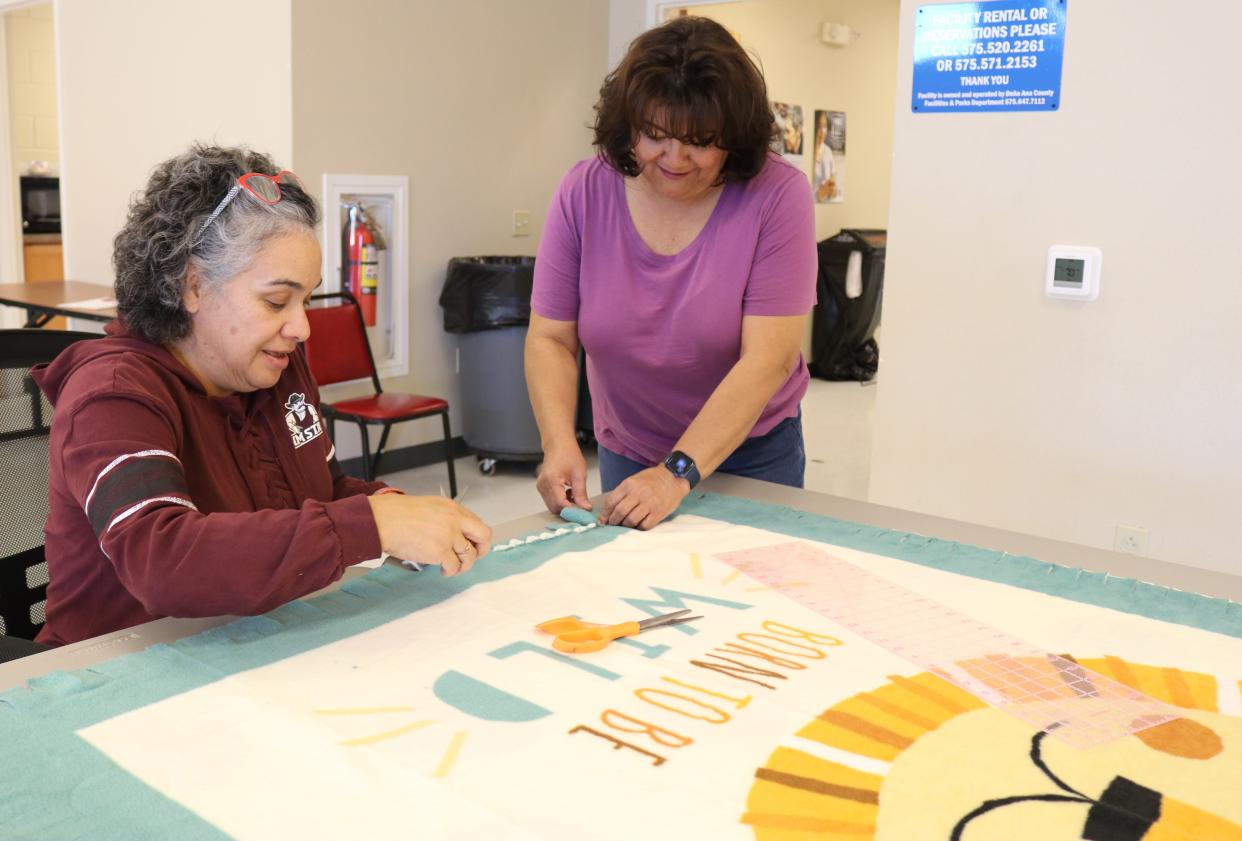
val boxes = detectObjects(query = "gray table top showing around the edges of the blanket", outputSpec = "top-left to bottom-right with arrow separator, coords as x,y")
0,475 -> 1242,691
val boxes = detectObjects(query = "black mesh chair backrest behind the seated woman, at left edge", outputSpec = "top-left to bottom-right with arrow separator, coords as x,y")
0,329 -> 99,640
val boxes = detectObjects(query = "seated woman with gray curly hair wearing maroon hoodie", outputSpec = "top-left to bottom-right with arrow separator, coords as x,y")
35,147 -> 491,643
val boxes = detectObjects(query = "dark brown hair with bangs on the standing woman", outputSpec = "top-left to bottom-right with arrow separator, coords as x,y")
594,16 -> 776,181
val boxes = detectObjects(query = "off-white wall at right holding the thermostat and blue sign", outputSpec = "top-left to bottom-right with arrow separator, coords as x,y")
871,0 -> 1242,573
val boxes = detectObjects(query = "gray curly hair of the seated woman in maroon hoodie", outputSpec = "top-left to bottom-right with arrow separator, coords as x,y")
112,144 -> 319,345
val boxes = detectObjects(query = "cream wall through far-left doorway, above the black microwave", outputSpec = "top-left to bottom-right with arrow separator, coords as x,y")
5,2 -> 60,174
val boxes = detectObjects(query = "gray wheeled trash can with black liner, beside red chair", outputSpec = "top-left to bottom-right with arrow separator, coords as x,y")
440,257 -> 543,475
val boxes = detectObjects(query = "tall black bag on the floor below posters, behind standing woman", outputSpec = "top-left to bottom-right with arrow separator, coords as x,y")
807,230 -> 887,383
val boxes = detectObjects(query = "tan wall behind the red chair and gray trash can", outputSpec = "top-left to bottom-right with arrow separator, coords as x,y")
293,0 -> 609,457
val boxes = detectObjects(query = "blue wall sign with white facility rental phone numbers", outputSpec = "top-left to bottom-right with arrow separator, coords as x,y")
910,0 -> 1066,114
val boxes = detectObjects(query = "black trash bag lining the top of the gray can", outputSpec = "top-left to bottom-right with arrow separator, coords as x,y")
440,257 -> 535,333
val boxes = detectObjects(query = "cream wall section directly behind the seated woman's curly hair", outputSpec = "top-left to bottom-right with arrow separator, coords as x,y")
56,0 -> 293,283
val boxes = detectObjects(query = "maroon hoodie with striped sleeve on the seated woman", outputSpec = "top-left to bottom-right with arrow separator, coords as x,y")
32,323 -> 384,643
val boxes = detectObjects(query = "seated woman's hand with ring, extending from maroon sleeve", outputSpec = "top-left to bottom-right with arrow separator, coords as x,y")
368,493 -> 492,575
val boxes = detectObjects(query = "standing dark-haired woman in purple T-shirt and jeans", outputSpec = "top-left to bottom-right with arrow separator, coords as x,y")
525,17 -> 816,528
